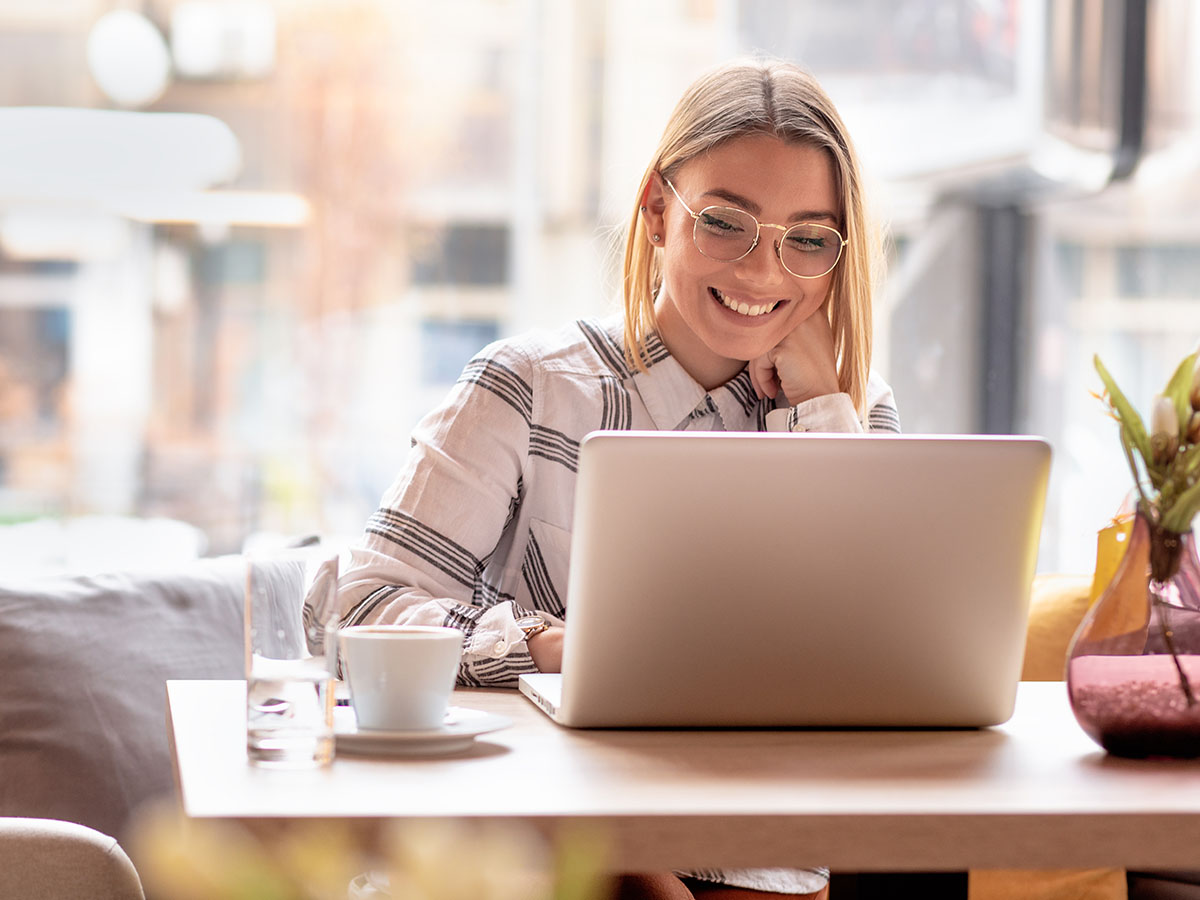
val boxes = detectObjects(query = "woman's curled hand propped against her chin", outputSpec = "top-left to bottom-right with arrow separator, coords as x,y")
748,305 -> 841,406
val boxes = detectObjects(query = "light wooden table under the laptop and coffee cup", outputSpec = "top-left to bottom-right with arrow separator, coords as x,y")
167,682 -> 1200,871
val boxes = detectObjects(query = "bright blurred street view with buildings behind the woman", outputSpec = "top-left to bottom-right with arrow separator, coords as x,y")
0,0 -> 1200,571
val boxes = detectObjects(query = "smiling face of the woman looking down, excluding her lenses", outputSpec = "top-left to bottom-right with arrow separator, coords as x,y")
643,134 -> 841,389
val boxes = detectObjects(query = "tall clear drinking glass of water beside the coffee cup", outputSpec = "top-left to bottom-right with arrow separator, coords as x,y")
246,547 -> 337,768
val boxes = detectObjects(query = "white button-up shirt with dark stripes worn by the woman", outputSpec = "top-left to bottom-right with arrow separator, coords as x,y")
338,317 -> 900,686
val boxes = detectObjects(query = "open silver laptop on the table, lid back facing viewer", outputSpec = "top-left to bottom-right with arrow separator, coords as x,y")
520,432 -> 1050,727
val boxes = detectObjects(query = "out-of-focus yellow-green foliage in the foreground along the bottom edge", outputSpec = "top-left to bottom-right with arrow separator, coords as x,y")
128,808 -> 612,900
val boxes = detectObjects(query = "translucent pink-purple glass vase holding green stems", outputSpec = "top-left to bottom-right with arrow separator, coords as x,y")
1067,512 -> 1200,757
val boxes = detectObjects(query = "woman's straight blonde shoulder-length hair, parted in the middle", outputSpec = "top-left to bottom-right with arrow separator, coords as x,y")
624,60 -> 881,415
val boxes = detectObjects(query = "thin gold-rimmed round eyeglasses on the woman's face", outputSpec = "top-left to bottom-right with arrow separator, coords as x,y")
662,178 -> 850,278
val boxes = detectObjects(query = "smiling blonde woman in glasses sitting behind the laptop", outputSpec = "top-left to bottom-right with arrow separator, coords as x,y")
340,62 -> 899,900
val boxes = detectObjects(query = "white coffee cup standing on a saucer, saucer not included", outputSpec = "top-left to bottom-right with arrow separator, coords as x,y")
337,625 -> 462,731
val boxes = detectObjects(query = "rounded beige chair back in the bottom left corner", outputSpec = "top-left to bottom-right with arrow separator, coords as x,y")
0,817 -> 145,900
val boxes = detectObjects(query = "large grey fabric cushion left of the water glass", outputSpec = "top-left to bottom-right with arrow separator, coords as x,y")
0,557 -> 244,838
